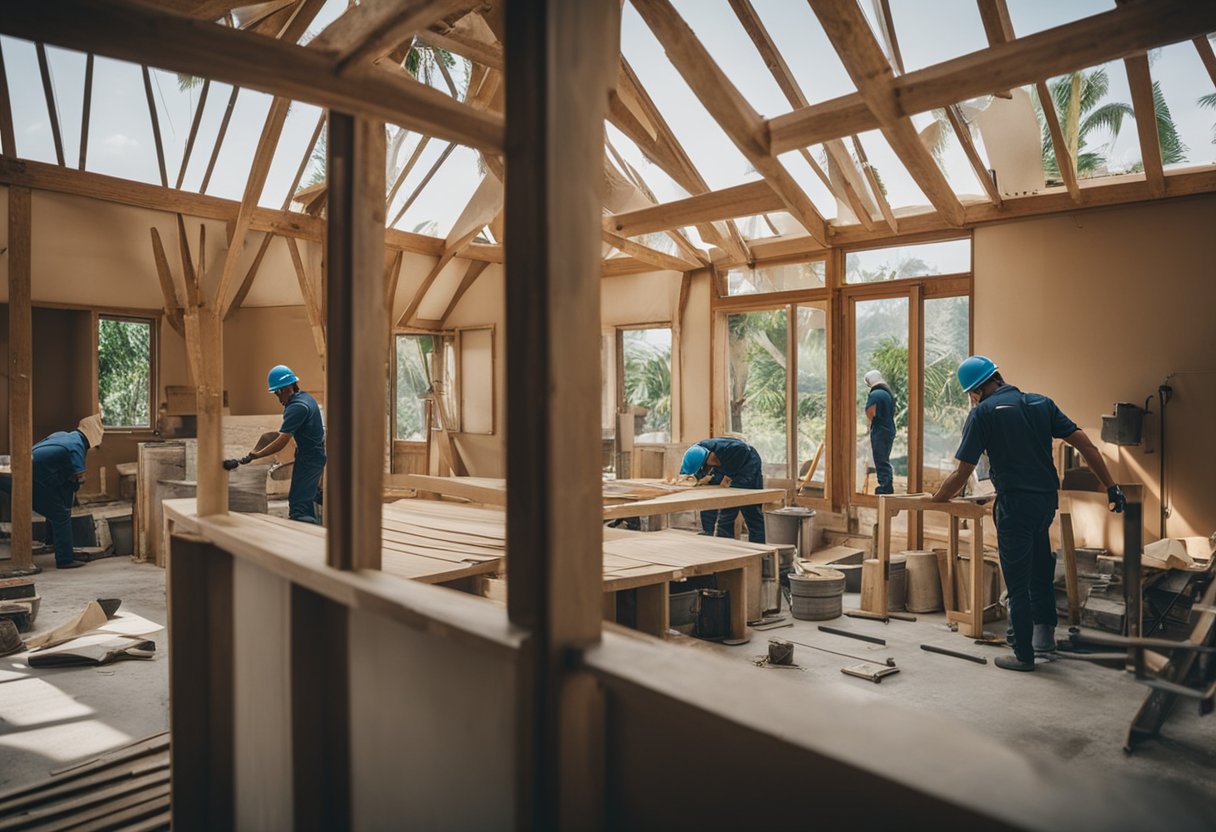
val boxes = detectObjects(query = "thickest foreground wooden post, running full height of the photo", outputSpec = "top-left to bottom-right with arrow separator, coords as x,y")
503,0 -> 620,830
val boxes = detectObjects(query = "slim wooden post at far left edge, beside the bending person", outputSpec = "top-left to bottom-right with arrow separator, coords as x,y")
7,187 -> 34,574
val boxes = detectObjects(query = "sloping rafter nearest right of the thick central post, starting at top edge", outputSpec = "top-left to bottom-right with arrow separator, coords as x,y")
634,0 -> 827,242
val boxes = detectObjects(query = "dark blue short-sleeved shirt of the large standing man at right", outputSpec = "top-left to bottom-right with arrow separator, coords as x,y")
955,384 -> 1077,494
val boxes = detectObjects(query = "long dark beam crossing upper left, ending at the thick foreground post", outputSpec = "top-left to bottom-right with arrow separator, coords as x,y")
0,0 -> 502,151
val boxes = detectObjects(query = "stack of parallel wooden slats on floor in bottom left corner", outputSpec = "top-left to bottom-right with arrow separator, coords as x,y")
0,732 -> 169,832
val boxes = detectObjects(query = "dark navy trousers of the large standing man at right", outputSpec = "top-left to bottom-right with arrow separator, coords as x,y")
996,491 -> 1057,662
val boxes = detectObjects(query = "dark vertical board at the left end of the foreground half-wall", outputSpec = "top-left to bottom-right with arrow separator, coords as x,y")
165,534 -> 236,832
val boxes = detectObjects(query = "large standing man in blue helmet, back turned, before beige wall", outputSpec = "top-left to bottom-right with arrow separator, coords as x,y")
930,355 -> 1126,670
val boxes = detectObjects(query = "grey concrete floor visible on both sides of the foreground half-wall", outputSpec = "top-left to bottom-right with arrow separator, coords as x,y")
0,555 -> 1216,808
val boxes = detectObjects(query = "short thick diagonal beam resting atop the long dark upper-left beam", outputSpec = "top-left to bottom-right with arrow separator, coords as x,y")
309,0 -> 468,75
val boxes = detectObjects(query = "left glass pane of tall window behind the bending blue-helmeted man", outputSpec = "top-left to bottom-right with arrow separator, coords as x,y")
726,308 -> 789,477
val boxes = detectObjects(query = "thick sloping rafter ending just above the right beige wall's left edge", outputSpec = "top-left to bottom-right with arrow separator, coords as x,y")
810,0 -> 963,225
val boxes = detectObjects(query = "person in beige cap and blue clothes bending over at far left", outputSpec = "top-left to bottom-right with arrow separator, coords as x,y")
0,414 -> 106,569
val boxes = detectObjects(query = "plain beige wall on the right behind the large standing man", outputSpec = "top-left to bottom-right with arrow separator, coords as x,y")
975,196 -> 1216,552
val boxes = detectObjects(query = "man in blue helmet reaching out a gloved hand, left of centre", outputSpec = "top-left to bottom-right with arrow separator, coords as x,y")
224,364 -> 325,524
